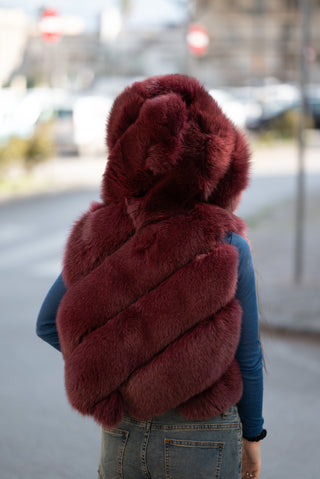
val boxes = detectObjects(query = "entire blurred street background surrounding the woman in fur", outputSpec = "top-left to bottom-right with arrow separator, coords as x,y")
0,0 -> 320,479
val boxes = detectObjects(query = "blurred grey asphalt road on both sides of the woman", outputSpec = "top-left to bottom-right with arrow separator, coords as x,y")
0,185 -> 320,479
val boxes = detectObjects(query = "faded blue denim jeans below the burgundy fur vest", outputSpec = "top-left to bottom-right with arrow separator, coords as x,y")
98,406 -> 242,479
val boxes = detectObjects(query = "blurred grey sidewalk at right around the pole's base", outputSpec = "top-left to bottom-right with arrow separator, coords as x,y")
249,191 -> 320,338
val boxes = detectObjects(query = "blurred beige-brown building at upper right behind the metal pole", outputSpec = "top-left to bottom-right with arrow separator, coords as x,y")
189,0 -> 320,85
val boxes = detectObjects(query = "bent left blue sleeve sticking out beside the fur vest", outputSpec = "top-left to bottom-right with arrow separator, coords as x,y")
36,275 -> 67,351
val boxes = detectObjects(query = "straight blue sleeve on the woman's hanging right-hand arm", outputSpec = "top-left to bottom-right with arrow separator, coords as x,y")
229,233 -> 264,438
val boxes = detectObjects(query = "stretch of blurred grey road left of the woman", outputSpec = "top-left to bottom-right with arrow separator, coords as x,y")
0,191 -> 100,479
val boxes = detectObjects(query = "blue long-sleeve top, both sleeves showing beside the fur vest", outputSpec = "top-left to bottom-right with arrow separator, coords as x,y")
36,233 -> 264,438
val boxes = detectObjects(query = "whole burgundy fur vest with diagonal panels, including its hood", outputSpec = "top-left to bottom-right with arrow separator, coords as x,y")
57,75 -> 249,426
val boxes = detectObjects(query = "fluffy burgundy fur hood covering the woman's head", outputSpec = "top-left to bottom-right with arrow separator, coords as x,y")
102,74 -> 249,209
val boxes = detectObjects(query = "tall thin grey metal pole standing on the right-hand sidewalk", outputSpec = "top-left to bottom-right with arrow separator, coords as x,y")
294,0 -> 310,284
